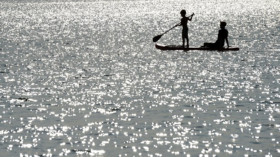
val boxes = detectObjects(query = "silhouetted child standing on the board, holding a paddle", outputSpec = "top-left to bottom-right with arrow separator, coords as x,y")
177,10 -> 194,48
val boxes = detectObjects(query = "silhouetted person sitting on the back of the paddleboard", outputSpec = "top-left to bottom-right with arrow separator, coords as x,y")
203,22 -> 229,49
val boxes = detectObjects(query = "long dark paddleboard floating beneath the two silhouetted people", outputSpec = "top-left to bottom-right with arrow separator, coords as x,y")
155,44 -> 239,51
